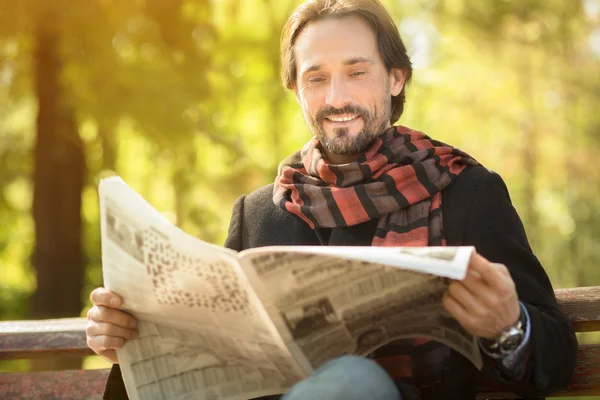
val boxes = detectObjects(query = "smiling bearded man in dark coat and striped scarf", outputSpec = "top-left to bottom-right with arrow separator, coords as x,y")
87,0 -> 577,400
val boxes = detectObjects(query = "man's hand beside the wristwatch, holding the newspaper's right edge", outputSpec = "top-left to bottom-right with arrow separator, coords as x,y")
443,253 -> 521,339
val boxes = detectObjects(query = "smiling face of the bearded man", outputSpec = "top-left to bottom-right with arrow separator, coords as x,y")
294,16 -> 404,156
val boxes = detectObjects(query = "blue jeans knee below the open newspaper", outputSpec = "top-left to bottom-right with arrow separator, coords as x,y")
281,356 -> 401,400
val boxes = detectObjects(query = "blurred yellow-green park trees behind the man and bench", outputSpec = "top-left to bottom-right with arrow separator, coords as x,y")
0,0 -> 600,394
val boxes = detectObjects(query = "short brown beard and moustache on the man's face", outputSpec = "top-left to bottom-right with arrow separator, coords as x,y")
307,93 -> 392,156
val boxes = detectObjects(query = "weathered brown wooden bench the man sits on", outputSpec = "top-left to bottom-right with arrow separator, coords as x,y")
0,286 -> 600,400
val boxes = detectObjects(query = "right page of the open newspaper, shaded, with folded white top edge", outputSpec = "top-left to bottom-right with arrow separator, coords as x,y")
241,247 -> 482,373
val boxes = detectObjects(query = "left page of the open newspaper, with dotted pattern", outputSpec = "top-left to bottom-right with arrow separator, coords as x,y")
99,177 -> 304,400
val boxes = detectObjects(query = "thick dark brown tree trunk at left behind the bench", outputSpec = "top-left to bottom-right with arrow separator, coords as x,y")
32,18 -> 85,340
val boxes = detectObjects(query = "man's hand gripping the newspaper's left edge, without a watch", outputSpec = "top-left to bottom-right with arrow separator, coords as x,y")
85,287 -> 138,364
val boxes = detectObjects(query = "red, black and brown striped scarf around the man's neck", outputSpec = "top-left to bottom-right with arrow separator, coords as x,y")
273,126 -> 479,398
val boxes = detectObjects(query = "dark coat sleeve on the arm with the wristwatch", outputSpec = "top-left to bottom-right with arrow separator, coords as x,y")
465,171 -> 577,397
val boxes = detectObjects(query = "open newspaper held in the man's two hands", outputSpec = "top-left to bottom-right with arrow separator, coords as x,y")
99,177 -> 482,400
